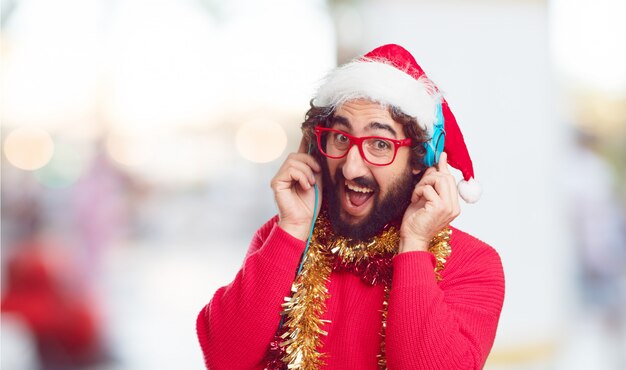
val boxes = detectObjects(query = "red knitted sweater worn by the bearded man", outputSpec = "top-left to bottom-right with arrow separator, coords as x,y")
197,217 -> 504,370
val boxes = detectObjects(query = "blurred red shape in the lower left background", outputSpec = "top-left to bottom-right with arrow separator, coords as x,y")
0,215 -> 107,370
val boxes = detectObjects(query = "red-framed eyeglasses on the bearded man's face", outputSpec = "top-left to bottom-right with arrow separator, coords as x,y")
314,127 -> 412,166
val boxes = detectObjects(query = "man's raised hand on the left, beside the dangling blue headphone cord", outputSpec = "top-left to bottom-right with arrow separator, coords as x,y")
271,138 -> 322,240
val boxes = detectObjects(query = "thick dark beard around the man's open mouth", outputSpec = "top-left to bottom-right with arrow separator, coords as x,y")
322,161 -> 414,242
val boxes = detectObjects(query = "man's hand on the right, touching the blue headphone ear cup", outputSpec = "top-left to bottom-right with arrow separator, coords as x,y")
399,152 -> 461,253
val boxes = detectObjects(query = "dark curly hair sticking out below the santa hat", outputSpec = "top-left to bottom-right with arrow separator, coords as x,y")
302,100 -> 430,173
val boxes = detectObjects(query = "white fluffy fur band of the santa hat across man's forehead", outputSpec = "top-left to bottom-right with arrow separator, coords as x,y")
313,59 -> 441,134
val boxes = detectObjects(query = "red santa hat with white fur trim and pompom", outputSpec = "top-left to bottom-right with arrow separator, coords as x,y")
313,44 -> 482,203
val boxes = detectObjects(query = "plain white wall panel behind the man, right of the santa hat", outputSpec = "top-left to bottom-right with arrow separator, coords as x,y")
346,1 -> 572,360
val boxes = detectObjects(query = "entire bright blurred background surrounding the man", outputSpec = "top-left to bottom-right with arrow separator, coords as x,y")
0,0 -> 626,370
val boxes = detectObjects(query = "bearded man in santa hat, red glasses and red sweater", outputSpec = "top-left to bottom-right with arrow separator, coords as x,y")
197,45 -> 504,370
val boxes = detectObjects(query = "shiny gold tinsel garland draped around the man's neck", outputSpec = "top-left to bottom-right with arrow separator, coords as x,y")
267,212 -> 451,370
